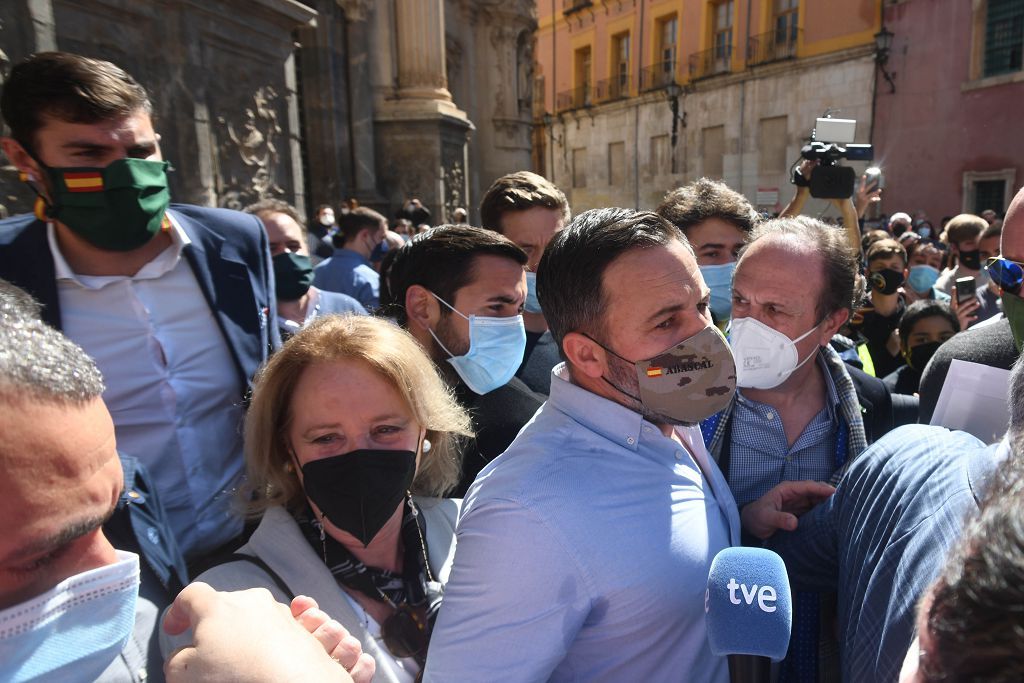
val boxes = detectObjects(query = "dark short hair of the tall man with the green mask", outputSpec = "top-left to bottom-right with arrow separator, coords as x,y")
0,52 -> 153,151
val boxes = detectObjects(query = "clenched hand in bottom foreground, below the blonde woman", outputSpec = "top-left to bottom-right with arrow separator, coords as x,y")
164,583 -> 352,683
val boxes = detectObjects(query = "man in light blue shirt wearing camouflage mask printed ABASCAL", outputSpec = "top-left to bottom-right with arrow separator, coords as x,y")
424,209 -> 830,682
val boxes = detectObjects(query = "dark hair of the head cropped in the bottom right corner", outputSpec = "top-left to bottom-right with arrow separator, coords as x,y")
923,434 -> 1024,682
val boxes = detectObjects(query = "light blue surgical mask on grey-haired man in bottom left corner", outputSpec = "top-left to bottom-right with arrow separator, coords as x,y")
0,550 -> 139,682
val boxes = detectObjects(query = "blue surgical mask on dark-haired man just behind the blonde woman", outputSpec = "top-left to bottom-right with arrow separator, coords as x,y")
430,292 -> 526,395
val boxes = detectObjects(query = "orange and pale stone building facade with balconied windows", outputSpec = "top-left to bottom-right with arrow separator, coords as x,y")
535,0 -> 881,215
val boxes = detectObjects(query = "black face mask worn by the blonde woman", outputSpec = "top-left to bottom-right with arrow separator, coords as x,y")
302,449 -> 416,547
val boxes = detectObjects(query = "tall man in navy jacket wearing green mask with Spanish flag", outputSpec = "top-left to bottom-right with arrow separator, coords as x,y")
0,52 -> 280,561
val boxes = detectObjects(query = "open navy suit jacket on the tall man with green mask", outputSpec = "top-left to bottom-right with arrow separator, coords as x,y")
0,204 -> 281,386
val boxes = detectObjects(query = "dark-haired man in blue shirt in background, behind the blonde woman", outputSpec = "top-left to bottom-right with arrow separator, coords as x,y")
313,207 -> 387,310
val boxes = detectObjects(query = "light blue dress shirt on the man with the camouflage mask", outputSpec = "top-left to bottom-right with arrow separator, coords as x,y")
424,364 -> 739,683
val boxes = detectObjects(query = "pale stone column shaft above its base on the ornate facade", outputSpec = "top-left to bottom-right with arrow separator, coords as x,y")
394,0 -> 452,101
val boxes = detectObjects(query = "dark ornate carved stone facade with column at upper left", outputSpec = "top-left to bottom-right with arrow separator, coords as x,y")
0,0 -> 536,222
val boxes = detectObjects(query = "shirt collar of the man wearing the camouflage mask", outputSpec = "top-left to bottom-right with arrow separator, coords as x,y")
548,362 -> 643,451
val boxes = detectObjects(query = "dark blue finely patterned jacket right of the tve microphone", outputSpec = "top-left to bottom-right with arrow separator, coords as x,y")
769,425 -> 1005,681
